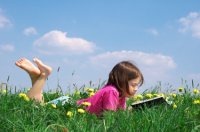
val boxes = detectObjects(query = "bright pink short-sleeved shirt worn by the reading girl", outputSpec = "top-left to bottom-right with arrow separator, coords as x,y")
77,85 -> 126,115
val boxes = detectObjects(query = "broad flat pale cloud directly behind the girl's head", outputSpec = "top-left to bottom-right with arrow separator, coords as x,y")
90,51 -> 176,82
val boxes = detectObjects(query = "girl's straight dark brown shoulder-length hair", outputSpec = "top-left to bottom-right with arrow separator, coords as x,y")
106,61 -> 144,97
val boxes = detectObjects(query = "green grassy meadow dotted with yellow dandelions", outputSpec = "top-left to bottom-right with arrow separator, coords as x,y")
0,81 -> 200,132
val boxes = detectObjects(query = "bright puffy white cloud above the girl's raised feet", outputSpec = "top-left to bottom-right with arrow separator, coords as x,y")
34,30 -> 95,54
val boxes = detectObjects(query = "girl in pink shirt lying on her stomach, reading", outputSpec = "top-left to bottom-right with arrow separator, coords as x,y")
15,58 -> 144,116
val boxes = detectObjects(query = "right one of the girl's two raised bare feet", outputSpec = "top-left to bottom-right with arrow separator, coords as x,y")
33,58 -> 52,77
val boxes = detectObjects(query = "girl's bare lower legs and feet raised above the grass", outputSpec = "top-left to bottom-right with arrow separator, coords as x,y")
15,58 -> 52,102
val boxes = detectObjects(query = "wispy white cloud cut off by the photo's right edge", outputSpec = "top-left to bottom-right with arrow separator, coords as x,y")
179,12 -> 200,39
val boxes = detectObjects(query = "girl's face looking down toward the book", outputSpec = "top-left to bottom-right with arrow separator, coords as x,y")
125,77 -> 140,97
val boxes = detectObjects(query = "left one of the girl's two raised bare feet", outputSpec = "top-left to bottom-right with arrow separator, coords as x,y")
15,58 -> 41,81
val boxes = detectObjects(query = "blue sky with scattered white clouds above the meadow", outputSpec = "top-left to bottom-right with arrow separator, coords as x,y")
0,0 -> 200,94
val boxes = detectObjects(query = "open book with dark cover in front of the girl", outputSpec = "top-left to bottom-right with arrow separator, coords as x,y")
131,96 -> 168,109
